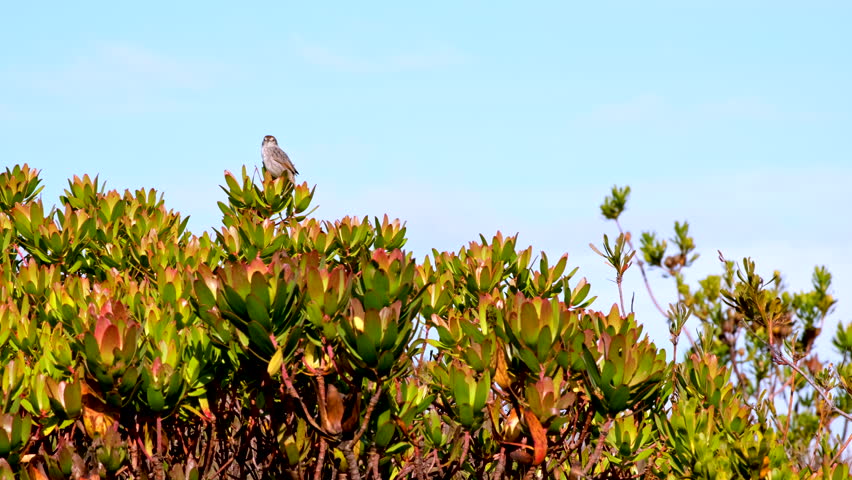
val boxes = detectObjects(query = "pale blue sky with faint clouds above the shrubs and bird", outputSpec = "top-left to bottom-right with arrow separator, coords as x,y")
0,1 -> 852,351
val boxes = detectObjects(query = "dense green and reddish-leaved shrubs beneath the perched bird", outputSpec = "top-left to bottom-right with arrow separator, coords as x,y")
0,166 -> 852,480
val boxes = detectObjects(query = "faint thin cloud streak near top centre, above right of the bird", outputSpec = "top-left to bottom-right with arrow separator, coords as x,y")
292,36 -> 465,73
